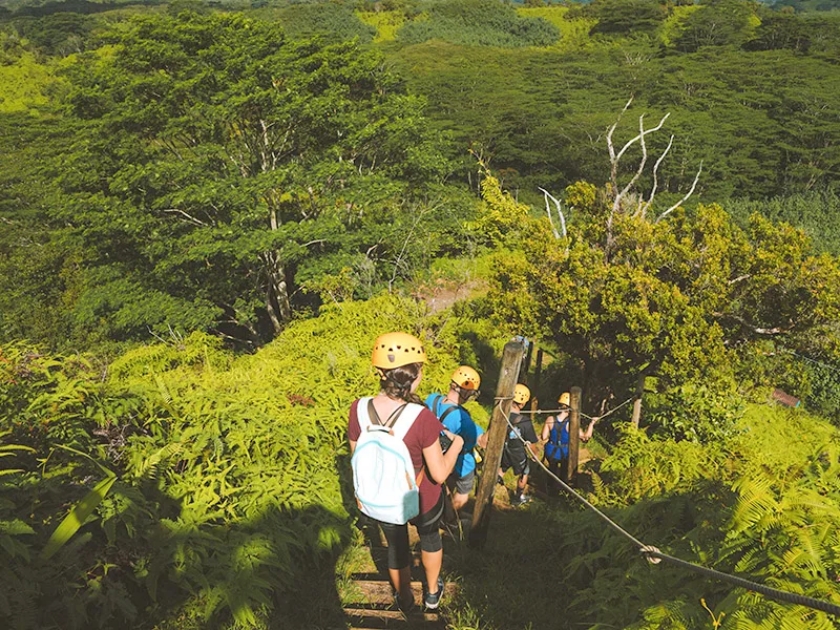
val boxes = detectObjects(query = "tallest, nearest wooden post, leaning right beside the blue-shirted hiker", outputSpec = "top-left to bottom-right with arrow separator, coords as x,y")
469,341 -> 525,548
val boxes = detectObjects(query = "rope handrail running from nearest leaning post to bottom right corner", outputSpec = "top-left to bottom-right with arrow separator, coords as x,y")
492,399 -> 840,616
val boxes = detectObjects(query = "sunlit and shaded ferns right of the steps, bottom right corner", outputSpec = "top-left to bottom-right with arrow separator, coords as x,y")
459,404 -> 840,630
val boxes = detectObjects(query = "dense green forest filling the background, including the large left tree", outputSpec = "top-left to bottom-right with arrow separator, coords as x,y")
0,0 -> 840,349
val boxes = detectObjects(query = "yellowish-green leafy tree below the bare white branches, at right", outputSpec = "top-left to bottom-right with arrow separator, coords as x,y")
482,180 -> 840,437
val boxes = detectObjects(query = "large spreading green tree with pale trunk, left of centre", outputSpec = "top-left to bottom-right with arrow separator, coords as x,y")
54,11 -> 446,342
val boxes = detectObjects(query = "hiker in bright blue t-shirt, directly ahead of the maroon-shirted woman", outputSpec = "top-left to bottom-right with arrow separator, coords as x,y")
426,365 -> 487,511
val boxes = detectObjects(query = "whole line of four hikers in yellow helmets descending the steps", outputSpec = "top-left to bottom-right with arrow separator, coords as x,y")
347,332 -> 594,613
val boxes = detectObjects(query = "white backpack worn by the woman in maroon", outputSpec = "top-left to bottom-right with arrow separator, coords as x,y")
350,397 -> 425,525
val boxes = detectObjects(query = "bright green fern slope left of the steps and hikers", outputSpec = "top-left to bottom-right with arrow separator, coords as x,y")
0,297 -> 498,630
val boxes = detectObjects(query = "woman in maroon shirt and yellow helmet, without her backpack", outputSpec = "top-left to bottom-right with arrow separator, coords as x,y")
347,332 -> 463,612
